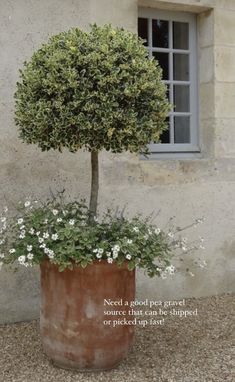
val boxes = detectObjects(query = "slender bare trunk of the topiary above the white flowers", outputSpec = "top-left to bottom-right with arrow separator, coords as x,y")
89,151 -> 99,220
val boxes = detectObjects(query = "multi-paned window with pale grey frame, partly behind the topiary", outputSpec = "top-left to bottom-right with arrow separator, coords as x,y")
138,8 -> 200,153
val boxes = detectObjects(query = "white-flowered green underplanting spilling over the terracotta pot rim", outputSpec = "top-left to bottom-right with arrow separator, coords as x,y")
0,200 -> 175,277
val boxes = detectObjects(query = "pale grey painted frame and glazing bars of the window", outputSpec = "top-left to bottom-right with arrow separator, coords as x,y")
138,8 -> 200,157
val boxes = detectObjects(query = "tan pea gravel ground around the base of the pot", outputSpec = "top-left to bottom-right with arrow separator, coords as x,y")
0,295 -> 235,382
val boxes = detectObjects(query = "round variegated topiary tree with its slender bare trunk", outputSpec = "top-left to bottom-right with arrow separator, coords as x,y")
15,25 -> 169,216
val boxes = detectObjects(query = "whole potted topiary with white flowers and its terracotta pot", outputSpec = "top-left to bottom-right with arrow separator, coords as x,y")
0,25 -> 175,370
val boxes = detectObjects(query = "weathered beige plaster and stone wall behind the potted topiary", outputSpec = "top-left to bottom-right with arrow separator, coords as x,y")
0,0 -> 235,322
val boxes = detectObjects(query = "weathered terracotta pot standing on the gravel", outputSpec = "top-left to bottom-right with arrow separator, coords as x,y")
40,260 -> 135,370
